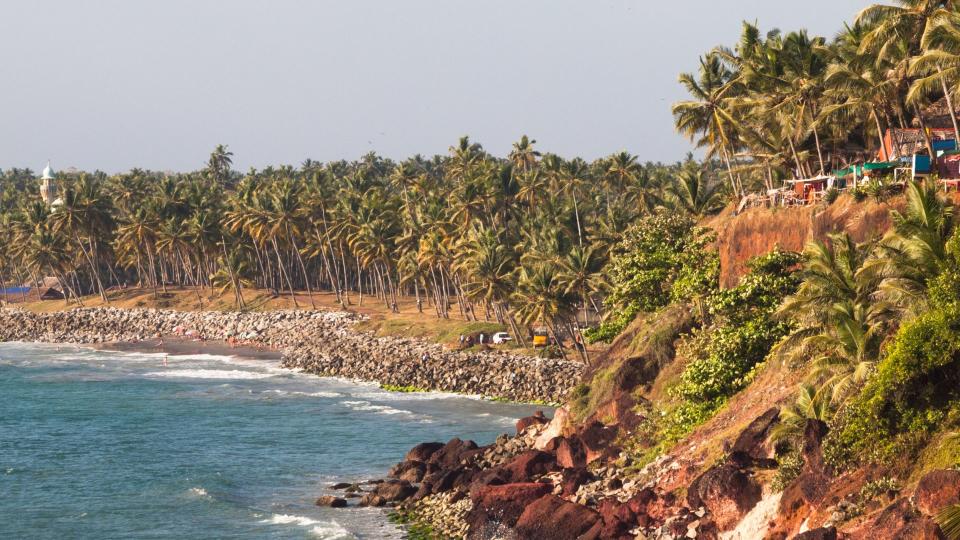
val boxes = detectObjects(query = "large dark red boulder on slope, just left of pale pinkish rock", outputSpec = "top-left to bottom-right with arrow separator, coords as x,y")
687,464 -> 762,531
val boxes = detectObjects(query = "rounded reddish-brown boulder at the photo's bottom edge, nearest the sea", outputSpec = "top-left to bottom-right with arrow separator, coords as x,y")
514,495 -> 600,540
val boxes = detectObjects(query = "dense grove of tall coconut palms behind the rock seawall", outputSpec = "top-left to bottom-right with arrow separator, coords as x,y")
0,143 -> 723,359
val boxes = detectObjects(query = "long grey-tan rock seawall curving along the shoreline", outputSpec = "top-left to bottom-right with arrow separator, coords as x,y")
0,308 -> 583,403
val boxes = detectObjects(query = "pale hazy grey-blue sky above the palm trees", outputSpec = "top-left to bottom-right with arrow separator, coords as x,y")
0,0 -> 868,173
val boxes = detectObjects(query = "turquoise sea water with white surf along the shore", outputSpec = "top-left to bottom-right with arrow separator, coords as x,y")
0,343 -> 548,539
